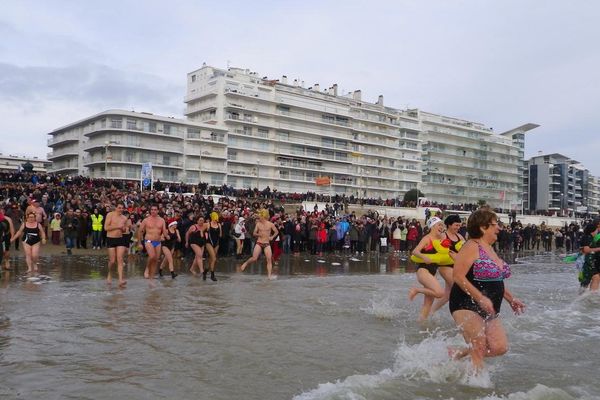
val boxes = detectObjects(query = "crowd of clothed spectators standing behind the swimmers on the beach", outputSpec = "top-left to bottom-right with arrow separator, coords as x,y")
0,172 -> 580,257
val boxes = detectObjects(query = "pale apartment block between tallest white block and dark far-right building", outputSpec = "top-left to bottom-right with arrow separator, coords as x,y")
419,112 -> 538,210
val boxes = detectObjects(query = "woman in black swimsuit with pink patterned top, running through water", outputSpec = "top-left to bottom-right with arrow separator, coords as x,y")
449,208 -> 525,371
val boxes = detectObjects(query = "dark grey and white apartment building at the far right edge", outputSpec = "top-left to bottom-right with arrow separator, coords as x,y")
524,153 -> 599,216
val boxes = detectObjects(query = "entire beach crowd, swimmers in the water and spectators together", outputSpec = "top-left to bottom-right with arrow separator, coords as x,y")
0,173 -> 600,376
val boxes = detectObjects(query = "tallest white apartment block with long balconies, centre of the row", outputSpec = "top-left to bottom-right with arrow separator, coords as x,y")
185,66 -> 421,198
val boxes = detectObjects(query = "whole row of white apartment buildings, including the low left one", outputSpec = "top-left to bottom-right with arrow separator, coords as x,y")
48,65 -> 537,209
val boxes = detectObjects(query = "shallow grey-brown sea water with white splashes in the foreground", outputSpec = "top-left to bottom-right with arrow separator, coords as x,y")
0,254 -> 600,400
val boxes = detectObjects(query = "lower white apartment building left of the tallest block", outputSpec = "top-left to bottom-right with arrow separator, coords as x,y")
48,110 -> 227,184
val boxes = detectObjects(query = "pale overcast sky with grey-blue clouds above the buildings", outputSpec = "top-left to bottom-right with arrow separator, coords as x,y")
0,0 -> 600,175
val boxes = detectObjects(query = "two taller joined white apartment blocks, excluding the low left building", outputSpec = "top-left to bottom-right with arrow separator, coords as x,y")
185,66 -> 537,208
